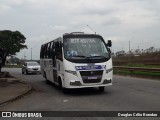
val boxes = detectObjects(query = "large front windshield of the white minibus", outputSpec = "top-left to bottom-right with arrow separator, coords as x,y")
64,38 -> 109,59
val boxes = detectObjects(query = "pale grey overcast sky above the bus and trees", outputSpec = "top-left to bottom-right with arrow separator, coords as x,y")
0,0 -> 160,59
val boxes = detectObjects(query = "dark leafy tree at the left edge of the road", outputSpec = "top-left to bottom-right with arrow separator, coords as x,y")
0,30 -> 27,72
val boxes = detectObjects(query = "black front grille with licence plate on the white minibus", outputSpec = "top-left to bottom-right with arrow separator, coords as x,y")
80,70 -> 103,83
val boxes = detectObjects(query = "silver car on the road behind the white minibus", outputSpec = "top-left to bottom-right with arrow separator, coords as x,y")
22,61 -> 40,74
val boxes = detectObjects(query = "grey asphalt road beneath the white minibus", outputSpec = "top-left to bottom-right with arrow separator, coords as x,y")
0,69 -> 160,120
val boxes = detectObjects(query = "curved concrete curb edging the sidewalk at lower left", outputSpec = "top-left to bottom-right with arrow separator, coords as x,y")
0,81 -> 32,106
